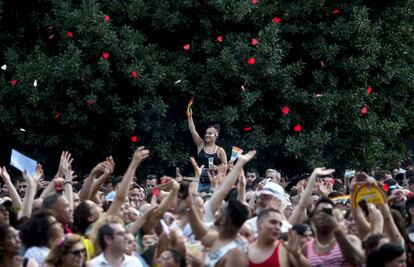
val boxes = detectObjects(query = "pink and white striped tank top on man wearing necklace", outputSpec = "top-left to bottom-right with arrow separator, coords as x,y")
306,239 -> 352,267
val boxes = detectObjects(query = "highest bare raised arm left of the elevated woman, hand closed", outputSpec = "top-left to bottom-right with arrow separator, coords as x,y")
107,146 -> 150,215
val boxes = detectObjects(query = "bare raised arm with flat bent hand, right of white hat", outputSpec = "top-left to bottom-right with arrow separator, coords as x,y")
289,168 -> 335,225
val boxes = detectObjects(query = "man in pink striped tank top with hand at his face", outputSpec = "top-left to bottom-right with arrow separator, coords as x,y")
302,197 -> 365,267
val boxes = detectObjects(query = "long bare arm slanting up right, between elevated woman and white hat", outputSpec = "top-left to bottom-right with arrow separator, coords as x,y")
209,150 -> 256,217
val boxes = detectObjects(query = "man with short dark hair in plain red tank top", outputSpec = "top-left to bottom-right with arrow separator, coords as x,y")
249,208 -> 309,267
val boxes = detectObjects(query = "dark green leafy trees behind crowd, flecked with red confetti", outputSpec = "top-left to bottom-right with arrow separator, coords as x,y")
0,0 -> 414,179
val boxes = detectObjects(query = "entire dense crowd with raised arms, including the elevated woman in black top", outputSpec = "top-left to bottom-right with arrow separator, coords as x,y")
0,109 -> 414,267
